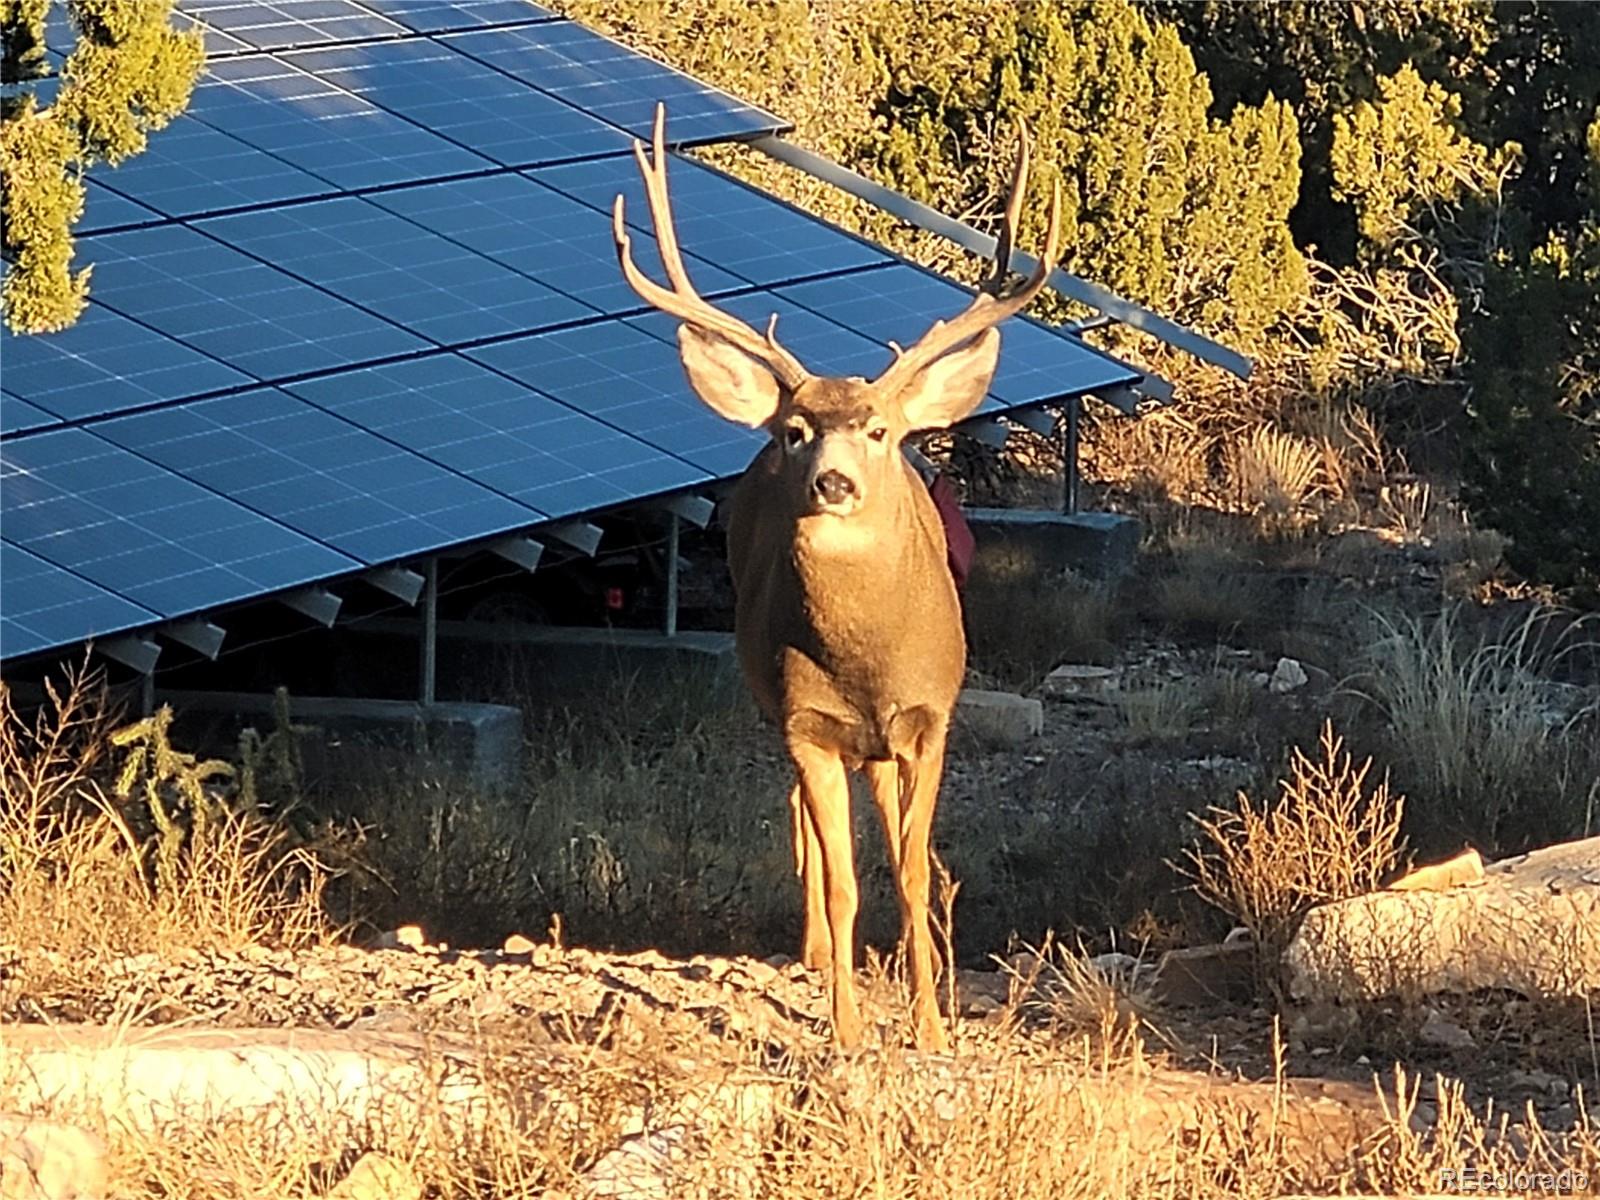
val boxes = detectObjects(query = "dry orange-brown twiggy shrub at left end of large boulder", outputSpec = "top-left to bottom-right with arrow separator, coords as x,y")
1179,722 -> 1405,962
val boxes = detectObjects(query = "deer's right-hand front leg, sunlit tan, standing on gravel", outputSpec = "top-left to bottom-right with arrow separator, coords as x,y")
880,722 -> 950,1051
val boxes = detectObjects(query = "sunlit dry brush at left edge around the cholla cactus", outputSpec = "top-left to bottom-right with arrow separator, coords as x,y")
0,669 -> 330,987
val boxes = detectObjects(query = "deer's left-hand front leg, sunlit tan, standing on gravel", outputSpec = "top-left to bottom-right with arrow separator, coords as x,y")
789,746 -> 861,1048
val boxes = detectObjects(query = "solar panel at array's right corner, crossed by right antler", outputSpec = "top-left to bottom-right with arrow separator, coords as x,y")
778,266 -> 1139,408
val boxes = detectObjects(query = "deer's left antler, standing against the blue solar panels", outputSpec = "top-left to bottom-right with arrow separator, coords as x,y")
611,104 -> 811,392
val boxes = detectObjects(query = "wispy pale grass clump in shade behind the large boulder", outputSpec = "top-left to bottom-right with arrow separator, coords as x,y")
1347,606 -> 1600,853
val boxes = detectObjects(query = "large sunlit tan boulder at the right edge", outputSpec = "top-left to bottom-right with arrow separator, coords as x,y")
1285,837 -> 1600,1000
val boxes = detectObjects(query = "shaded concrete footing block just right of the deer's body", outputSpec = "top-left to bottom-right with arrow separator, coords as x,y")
965,509 -> 1139,579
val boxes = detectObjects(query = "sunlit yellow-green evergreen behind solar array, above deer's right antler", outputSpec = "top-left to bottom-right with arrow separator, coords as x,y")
870,0 -> 1306,346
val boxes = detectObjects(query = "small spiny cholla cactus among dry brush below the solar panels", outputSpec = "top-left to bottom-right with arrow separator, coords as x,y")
110,704 -> 234,893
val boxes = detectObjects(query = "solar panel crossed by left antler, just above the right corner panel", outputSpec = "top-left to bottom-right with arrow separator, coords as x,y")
528,155 -> 893,286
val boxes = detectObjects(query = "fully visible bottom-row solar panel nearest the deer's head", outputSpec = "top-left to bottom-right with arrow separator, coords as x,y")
288,350 -> 707,517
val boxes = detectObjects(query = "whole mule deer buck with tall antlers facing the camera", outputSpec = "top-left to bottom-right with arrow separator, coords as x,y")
611,107 -> 1061,1050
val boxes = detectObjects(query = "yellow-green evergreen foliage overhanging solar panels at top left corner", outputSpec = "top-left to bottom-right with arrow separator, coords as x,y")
0,0 -> 205,333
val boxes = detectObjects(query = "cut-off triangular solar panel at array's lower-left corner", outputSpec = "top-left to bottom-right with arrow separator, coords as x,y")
0,541 -> 158,658
